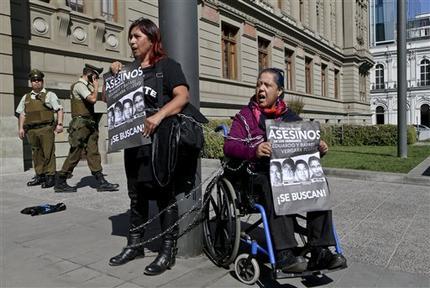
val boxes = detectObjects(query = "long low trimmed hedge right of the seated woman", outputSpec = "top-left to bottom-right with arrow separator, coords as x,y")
321,125 -> 416,146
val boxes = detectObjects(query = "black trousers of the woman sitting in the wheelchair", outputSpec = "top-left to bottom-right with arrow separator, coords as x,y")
250,174 -> 336,250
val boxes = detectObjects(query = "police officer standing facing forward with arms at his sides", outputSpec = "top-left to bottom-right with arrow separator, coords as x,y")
16,69 -> 64,188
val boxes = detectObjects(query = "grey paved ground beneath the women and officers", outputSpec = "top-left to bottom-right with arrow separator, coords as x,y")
0,158 -> 430,288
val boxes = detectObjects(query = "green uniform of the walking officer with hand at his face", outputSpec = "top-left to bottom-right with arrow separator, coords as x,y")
60,78 -> 102,175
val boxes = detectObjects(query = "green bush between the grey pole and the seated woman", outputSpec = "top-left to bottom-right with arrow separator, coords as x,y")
202,119 -> 232,159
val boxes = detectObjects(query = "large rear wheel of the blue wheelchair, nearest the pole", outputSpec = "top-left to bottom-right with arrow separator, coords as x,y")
203,177 -> 240,267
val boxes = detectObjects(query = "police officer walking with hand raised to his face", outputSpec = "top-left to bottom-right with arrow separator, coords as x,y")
54,64 -> 119,192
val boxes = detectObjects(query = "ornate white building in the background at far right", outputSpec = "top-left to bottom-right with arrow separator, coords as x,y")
370,1 -> 430,126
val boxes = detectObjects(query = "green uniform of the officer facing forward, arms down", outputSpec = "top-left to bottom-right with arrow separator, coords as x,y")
16,89 -> 63,175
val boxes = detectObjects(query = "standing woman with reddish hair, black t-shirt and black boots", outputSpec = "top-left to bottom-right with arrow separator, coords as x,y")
109,18 -> 189,275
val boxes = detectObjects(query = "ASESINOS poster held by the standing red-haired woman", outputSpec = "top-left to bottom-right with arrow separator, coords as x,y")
103,61 -> 151,152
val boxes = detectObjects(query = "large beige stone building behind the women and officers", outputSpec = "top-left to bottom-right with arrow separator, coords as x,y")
0,0 -> 373,172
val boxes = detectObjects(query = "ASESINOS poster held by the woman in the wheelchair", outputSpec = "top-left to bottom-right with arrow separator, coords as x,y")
266,120 -> 330,215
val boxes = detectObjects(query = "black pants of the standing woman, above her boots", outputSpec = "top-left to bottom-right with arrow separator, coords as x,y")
127,179 -> 179,240
